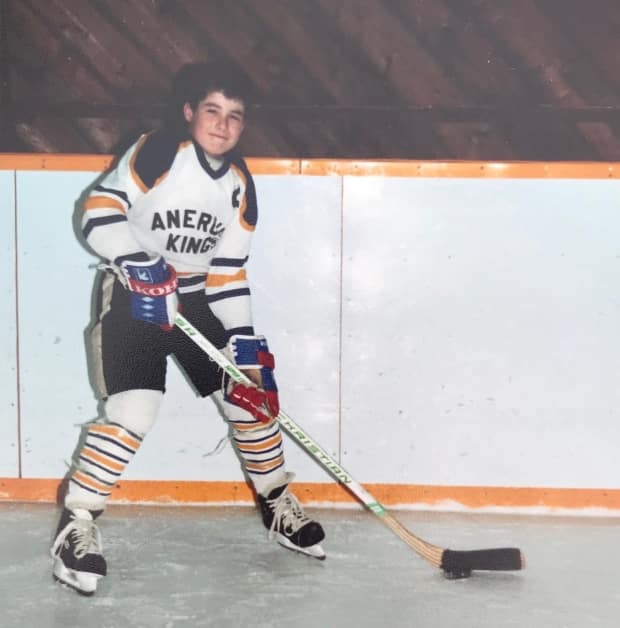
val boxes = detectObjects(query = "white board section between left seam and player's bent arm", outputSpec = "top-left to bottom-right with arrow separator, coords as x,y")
17,172 -> 98,478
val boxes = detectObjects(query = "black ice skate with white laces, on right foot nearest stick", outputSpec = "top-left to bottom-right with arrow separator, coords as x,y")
258,473 -> 325,560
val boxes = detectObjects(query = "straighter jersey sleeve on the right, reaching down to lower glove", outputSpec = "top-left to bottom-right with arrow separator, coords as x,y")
206,160 -> 258,337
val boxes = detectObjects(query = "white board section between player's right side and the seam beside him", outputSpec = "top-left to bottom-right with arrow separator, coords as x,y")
249,176 -> 341,482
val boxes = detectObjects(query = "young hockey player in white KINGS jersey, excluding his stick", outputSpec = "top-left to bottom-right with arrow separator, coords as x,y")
52,64 -> 325,595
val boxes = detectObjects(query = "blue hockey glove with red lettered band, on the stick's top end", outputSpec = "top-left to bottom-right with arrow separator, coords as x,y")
120,255 -> 179,331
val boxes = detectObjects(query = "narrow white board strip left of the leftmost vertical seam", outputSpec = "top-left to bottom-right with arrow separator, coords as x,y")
0,171 -> 19,477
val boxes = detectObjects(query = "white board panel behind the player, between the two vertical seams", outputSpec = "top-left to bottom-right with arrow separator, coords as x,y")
12,172 -> 340,481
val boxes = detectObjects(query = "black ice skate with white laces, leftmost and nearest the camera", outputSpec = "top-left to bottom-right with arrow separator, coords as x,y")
51,508 -> 107,595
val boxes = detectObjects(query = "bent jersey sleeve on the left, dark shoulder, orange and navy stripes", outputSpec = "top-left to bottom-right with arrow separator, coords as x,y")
82,132 -> 178,261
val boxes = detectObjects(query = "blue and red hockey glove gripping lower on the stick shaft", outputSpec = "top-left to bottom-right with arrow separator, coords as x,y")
224,336 -> 280,423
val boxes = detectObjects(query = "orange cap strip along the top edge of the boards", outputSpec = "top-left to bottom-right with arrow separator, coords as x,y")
0,153 -> 620,179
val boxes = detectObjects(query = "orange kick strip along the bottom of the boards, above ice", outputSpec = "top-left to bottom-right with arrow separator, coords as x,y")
0,478 -> 620,510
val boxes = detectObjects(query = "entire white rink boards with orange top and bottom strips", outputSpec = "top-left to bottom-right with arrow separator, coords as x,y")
0,155 -> 620,509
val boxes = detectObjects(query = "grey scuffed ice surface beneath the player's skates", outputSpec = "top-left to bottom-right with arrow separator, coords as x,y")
0,503 -> 620,628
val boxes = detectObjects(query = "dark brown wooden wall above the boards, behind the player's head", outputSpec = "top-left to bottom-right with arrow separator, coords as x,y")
0,0 -> 620,161
